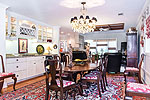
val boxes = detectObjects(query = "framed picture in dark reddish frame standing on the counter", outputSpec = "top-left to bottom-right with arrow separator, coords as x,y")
18,38 -> 28,53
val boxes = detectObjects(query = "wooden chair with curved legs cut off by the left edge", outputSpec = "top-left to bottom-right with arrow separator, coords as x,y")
0,55 -> 17,92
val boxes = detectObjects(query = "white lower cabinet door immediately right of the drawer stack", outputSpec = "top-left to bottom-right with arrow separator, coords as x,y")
27,61 -> 36,77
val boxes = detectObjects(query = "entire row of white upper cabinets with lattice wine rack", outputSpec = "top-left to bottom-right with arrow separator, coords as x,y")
6,14 -> 53,43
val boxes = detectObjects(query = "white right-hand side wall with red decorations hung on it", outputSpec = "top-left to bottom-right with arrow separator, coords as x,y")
136,0 -> 150,84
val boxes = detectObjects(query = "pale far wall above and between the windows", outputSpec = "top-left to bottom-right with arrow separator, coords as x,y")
84,31 -> 126,50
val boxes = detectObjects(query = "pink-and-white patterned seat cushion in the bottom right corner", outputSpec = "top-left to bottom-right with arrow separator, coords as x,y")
126,82 -> 150,93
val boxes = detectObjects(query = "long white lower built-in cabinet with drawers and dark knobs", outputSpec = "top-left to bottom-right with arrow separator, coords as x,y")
6,56 -> 45,84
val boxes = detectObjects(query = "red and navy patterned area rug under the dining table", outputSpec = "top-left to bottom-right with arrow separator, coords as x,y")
0,76 -> 143,100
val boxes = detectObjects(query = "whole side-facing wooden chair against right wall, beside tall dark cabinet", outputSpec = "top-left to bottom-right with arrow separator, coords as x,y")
124,54 -> 144,83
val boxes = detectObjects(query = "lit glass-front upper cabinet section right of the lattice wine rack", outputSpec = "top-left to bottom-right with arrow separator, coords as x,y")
37,25 -> 53,42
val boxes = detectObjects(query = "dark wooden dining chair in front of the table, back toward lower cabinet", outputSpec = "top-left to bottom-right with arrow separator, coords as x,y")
44,59 -> 76,100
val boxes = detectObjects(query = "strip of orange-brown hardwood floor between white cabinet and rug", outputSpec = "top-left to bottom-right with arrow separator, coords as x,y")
2,75 -> 45,94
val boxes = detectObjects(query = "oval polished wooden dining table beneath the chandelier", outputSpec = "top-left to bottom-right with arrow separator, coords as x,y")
56,62 -> 98,96
